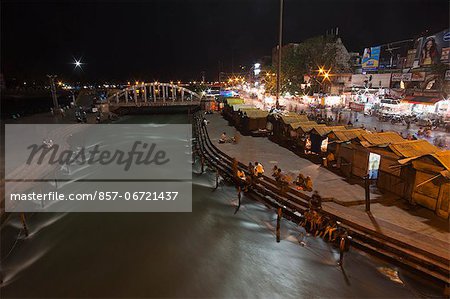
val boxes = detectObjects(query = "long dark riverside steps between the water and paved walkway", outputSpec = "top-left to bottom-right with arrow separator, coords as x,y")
196,115 -> 450,283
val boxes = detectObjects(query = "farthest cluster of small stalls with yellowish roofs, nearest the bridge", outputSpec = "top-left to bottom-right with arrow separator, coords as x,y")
222,98 -> 271,136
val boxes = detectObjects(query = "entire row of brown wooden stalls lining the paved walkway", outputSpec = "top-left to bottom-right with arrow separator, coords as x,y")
223,99 -> 450,219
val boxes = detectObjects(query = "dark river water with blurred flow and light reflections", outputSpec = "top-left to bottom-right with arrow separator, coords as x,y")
0,114 -> 442,298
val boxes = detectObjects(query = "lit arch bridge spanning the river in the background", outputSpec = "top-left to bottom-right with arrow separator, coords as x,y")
107,82 -> 202,108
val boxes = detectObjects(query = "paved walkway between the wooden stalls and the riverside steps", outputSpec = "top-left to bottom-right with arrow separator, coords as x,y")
206,114 -> 450,252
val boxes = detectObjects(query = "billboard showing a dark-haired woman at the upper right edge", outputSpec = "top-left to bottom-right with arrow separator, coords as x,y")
416,29 -> 450,66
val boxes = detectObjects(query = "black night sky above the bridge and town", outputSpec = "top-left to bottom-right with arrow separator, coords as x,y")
1,0 -> 449,81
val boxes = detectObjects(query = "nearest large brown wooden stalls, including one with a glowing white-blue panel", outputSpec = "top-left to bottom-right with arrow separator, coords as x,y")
328,129 -> 450,219
